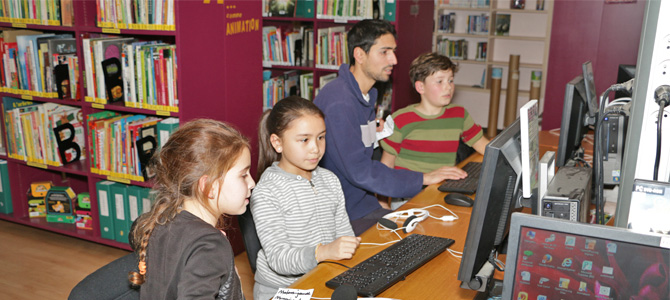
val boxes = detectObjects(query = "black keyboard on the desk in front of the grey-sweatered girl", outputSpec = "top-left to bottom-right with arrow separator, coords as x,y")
326,234 -> 454,297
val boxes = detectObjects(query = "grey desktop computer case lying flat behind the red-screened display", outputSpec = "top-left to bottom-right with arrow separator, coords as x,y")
540,167 -> 592,222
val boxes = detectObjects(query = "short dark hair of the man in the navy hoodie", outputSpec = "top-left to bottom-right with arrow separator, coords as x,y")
347,19 -> 397,66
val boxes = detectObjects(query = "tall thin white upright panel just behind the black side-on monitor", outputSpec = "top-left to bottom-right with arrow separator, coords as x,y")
519,100 -> 540,198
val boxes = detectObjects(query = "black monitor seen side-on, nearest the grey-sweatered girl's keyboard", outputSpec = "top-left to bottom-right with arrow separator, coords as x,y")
458,119 -> 522,291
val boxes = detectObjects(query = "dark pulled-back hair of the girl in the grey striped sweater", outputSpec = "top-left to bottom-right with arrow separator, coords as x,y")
256,96 -> 325,180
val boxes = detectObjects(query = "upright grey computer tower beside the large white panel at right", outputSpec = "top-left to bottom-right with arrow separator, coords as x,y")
600,105 -> 629,185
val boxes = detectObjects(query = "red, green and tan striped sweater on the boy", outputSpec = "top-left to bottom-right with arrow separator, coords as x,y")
381,104 -> 483,173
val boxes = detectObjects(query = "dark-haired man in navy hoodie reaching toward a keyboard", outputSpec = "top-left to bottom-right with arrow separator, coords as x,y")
314,20 -> 466,235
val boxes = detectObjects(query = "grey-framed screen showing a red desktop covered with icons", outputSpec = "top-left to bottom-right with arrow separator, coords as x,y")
503,213 -> 670,299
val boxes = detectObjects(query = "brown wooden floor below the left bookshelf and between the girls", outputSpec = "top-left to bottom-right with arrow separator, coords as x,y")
0,220 -> 254,300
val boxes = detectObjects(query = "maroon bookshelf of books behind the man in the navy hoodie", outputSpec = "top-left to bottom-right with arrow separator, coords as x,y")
262,0 -> 434,112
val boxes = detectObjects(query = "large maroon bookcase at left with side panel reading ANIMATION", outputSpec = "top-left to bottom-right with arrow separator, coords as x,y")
0,0 -> 262,252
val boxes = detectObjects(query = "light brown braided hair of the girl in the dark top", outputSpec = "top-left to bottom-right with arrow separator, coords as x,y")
129,119 -> 250,285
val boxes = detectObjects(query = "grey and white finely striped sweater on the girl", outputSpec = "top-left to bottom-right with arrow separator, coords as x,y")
250,162 -> 354,299
